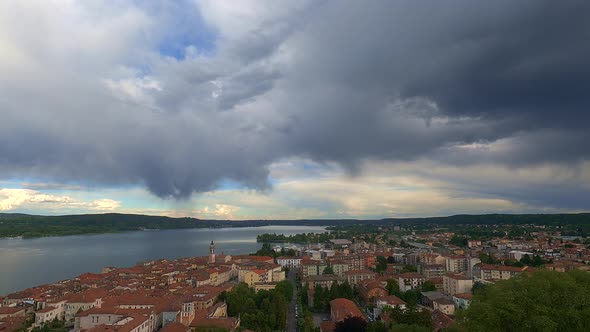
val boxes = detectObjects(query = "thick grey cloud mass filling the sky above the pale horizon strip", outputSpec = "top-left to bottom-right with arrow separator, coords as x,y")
0,1 -> 590,204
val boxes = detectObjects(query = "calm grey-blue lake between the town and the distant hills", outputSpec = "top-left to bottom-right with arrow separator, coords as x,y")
0,226 -> 325,295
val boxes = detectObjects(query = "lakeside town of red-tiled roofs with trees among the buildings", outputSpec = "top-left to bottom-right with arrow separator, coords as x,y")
0,220 -> 590,332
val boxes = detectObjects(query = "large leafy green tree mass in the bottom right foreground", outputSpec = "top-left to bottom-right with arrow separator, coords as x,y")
461,271 -> 590,331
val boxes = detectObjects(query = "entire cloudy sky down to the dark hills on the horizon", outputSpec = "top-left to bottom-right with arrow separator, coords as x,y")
0,0 -> 590,220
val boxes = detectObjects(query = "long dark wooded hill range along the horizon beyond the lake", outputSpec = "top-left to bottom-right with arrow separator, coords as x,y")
0,213 -> 590,238
